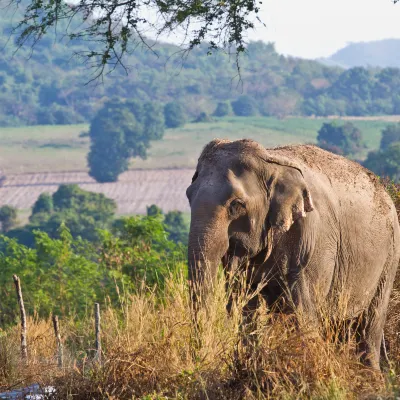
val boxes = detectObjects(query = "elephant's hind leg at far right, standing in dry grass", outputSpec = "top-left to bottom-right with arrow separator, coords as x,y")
359,262 -> 397,370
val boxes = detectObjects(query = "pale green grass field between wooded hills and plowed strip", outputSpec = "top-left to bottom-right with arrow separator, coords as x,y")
0,117 -> 390,174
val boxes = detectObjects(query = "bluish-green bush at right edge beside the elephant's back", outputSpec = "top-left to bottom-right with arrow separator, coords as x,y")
364,142 -> 400,182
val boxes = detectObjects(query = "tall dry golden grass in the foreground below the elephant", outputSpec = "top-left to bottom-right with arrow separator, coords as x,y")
0,278 -> 397,400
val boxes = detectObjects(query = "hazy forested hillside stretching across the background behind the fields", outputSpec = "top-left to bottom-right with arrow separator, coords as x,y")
0,13 -> 400,126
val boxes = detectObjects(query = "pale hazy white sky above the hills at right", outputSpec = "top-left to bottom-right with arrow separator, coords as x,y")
249,0 -> 400,58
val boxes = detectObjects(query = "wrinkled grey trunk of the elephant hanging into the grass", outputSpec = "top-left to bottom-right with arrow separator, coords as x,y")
188,211 -> 229,300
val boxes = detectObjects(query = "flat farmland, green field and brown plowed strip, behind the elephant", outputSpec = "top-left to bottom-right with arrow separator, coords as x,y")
0,117 -> 396,214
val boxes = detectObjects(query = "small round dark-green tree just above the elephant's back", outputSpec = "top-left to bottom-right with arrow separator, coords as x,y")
317,122 -> 364,156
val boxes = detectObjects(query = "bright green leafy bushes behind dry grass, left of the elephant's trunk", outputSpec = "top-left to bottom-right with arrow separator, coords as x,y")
0,217 -> 185,326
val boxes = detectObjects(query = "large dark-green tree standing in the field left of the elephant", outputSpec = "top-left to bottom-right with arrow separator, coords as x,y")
88,100 -> 164,182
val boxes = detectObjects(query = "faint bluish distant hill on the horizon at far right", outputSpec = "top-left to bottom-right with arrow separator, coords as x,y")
320,39 -> 400,68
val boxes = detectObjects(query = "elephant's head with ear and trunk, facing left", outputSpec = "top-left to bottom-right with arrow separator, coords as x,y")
186,140 -> 313,300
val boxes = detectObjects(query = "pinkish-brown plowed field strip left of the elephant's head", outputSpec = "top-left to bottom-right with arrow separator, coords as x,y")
0,169 -> 194,214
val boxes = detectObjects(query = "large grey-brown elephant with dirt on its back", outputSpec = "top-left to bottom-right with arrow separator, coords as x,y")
186,139 -> 400,370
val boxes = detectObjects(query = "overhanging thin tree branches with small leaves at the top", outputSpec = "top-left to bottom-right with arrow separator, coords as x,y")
11,0 -> 259,73
